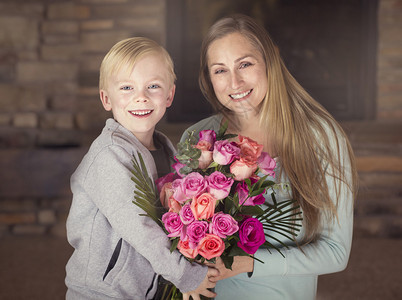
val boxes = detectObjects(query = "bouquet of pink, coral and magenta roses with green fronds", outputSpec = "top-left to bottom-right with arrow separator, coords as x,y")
132,123 -> 301,268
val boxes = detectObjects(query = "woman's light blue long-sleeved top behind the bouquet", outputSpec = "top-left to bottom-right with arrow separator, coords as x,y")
182,116 -> 353,300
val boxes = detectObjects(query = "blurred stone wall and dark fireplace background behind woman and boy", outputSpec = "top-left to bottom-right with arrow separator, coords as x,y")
0,0 -> 402,299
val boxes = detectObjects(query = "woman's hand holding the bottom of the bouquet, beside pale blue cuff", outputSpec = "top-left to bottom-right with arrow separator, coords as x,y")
205,256 -> 254,282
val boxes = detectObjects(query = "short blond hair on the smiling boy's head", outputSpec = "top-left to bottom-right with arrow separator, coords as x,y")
99,37 -> 176,90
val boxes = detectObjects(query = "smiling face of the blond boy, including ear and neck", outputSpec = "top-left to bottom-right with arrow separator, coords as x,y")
100,52 -> 175,149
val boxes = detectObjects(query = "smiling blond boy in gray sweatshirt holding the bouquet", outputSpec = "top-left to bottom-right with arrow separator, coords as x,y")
66,38 -> 217,299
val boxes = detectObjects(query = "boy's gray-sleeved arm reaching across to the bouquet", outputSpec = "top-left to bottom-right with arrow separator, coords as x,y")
85,146 -> 207,292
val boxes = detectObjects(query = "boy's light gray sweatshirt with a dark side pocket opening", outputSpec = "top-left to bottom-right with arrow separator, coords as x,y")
65,119 -> 207,299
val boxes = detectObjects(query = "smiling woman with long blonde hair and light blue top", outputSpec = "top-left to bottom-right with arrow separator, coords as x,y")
182,15 -> 357,300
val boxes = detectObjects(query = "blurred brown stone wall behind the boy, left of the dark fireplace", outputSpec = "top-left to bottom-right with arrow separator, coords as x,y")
0,0 -> 165,236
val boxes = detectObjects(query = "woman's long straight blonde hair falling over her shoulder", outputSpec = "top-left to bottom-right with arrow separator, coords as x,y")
199,15 -> 357,242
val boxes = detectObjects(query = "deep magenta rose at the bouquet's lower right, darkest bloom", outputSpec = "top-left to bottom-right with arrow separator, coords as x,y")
237,218 -> 265,254
